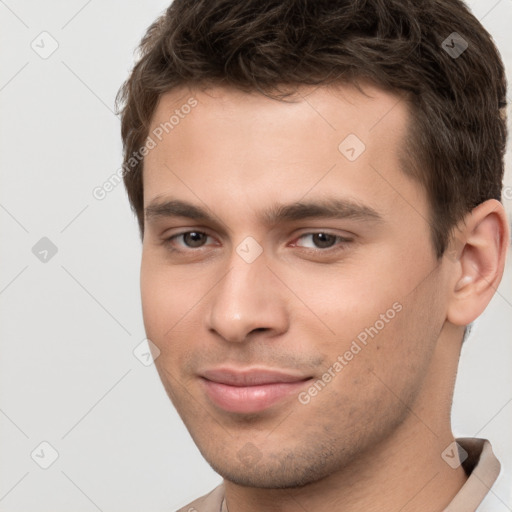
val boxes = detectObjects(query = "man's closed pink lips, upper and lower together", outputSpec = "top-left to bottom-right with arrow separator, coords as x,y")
200,368 -> 311,414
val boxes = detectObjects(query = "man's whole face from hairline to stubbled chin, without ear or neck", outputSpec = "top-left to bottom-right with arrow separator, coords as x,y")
141,85 -> 446,487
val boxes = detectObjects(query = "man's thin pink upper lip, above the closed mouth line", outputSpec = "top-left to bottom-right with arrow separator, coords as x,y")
200,368 -> 310,387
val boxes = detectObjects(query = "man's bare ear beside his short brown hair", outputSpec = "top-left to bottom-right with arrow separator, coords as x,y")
443,199 -> 510,325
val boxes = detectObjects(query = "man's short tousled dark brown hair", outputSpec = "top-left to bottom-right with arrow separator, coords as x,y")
116,0 -> 507,257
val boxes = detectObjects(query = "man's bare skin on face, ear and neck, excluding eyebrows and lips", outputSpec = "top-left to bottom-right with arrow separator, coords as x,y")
141,84 -> 507,512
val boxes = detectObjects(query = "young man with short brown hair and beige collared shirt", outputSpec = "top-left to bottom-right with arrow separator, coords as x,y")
119,0 -> 509,512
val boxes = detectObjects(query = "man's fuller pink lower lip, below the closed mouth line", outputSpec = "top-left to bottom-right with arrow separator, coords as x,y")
201,378 -> 310,414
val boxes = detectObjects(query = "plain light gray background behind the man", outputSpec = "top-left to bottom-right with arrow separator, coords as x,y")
0,0 -> 512,512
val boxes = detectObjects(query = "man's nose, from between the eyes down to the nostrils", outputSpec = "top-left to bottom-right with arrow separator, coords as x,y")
206,245 -> 288,343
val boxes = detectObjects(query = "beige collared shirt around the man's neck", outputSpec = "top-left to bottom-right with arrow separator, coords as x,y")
177,437 -> 501,512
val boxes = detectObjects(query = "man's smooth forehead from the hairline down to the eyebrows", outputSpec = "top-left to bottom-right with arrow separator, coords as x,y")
143,84 -> 424,228
